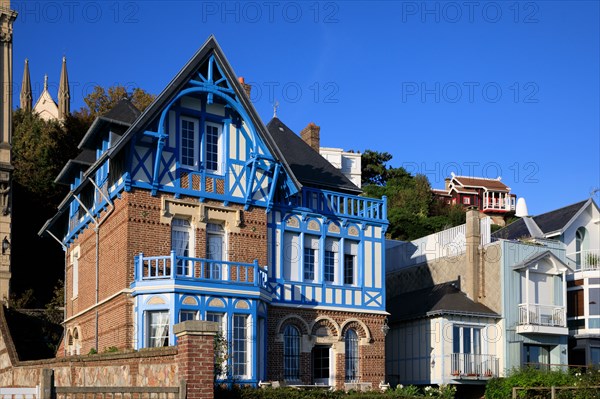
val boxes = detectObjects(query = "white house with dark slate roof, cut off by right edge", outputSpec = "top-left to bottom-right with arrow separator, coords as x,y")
493,198 -> 600,367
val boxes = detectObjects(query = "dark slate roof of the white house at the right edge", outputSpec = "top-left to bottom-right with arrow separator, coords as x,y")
492,200 -> 590,240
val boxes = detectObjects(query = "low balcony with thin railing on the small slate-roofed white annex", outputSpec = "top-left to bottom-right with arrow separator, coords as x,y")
444,353 -> 500,380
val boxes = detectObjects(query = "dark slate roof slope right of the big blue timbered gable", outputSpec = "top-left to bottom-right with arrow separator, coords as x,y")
267,117 -> 361,194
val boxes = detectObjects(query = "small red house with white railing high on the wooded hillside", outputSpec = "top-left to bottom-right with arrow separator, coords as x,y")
432,173 -> 516,226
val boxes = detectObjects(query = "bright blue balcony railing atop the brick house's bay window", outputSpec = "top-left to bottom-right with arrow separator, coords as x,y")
134,251 -> 267,292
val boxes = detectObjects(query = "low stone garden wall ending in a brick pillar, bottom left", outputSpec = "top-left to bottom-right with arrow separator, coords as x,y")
0,306 -> 217,399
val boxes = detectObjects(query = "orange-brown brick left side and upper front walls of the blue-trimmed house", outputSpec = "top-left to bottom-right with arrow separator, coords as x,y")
58,190 -> 267,356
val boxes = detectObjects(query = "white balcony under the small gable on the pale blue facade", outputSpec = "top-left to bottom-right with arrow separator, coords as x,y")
517,304 -> 569,335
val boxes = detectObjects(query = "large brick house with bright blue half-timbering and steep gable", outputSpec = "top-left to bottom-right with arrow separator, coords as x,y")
40,37 -> 387,388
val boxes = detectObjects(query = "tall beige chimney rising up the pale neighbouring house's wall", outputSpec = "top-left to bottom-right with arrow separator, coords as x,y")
463,208 -> 481,302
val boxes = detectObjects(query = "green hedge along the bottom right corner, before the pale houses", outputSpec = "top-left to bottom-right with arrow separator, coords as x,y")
485,368 -> 600,399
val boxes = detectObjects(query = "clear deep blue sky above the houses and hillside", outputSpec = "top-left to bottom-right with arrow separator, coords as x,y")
12,0 -> 600,214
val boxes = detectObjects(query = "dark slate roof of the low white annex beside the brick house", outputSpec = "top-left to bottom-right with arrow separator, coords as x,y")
386,281 -> 500,324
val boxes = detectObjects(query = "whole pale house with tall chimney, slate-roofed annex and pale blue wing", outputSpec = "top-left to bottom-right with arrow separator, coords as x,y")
386,210 -> 571,390
